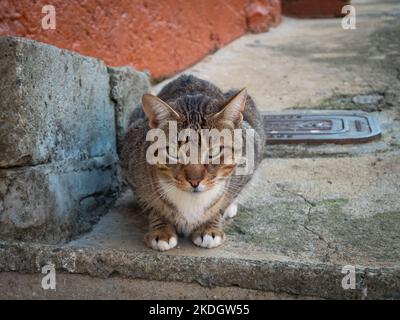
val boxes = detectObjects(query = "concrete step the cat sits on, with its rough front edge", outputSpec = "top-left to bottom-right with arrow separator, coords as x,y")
0,156 -> 400,298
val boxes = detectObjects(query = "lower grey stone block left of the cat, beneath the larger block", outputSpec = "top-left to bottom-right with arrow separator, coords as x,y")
0,156 -> 118,243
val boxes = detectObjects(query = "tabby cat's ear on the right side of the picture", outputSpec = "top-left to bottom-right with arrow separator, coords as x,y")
214,88 -> 247,128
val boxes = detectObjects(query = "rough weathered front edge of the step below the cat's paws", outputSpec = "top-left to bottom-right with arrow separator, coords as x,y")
0,242 -> 400,299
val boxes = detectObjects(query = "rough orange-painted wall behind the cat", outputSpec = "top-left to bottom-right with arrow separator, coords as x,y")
0,0 -> 280,78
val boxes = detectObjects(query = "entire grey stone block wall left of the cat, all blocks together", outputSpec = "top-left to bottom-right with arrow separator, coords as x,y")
0,37 -> 156,243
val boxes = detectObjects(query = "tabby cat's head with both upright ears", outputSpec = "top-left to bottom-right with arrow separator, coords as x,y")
142,89 -> 247,193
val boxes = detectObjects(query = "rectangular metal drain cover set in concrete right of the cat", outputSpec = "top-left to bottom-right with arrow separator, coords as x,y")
263,110 -> 381,144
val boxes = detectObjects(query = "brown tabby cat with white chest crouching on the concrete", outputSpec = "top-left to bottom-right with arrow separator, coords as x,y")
121,75 -> 265,251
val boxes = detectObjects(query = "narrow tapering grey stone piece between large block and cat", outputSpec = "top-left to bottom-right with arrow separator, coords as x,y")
108,67 -> 150,150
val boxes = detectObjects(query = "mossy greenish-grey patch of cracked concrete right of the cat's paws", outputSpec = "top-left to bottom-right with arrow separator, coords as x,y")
226,198 -> 400,261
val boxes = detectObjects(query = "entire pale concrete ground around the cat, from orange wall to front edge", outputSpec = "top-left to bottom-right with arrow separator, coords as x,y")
0,0 -> 400,299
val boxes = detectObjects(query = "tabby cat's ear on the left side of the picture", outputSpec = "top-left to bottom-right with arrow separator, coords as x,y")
142,93 -> 180,128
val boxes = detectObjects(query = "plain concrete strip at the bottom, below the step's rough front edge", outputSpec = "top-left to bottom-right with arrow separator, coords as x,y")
0,272 -> 310,300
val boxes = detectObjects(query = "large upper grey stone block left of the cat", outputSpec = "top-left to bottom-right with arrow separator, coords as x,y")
0,37 -> 116,168
